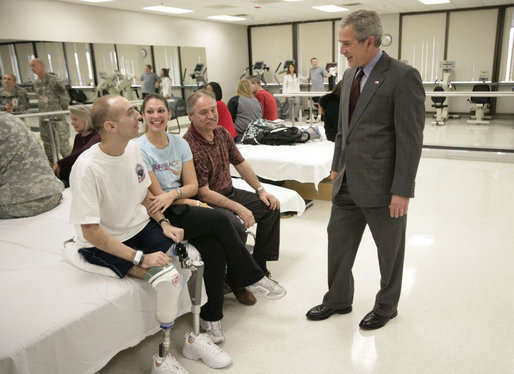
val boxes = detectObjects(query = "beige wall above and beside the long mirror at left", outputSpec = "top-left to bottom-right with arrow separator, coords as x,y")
0,0 -> 248,101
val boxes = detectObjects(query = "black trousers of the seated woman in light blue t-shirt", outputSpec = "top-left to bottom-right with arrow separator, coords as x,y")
164,205 -> 264,321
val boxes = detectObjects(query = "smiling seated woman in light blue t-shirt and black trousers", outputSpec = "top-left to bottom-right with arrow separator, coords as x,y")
137,94 -> 285,343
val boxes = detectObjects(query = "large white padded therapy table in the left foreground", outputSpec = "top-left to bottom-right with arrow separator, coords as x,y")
0,189 -> 200,374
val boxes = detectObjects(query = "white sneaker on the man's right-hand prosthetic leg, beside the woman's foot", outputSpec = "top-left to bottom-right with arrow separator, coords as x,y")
182,332 -> 232,369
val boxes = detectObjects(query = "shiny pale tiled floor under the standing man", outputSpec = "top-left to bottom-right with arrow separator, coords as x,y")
100,158 -> 514,374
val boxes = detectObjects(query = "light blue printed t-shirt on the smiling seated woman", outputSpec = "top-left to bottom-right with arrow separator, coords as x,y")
136,134 -> 193,192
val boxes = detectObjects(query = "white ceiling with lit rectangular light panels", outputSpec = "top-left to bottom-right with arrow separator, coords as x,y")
55,0 -> 514,25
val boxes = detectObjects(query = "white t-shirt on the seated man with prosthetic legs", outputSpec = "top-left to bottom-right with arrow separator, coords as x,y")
70,141 -> 151,248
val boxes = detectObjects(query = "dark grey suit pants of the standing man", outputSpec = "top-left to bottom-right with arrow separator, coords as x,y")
323,181 -> 407,316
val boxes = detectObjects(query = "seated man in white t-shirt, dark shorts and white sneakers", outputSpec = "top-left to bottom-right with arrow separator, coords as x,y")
70,95 -> 231,373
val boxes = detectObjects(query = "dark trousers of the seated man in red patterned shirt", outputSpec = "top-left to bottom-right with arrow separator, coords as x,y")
215,188 -> 280,270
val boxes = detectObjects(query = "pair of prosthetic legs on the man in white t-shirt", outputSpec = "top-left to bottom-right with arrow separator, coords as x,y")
149,243 -> 204,374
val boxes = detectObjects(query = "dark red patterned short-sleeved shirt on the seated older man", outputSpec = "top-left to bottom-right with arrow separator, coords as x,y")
184,124 -> 245,195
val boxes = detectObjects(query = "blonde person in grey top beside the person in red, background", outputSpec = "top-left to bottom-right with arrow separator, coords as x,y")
227,79 -> 262,142
